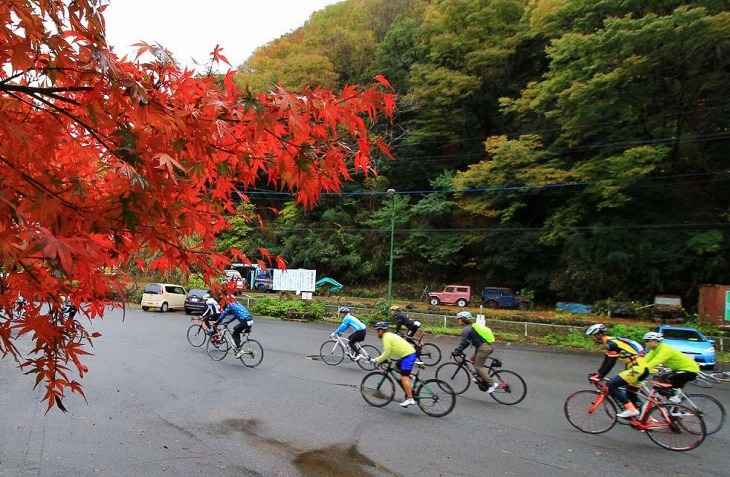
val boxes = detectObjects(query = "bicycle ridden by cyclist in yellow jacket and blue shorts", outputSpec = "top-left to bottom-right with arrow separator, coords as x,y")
360,360 -> 456,417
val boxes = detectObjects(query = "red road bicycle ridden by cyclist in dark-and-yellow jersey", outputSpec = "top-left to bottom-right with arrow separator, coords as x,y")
563,379 -> 707,452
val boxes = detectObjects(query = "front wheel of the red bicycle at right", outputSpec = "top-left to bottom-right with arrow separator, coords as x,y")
563,390 -> 617,434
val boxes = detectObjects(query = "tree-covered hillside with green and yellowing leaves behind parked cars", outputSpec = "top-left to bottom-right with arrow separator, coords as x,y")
222,0 -> 730,306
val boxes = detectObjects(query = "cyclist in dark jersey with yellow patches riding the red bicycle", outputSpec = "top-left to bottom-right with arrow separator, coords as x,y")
586,323 -> 649,418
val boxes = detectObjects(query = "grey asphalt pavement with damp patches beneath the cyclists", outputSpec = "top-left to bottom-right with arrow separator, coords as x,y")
0,310 -> 730,477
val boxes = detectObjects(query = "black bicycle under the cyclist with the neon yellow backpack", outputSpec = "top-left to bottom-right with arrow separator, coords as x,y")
436,354 -> 527,406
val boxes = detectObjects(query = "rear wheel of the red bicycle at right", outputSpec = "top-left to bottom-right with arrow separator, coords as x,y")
646,403 -> 706,452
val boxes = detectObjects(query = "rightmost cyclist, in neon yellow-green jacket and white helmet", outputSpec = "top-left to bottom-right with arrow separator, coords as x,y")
644,331 -> 700,404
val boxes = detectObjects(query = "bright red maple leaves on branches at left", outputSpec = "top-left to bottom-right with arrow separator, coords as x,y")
0,0 -> 393,410
